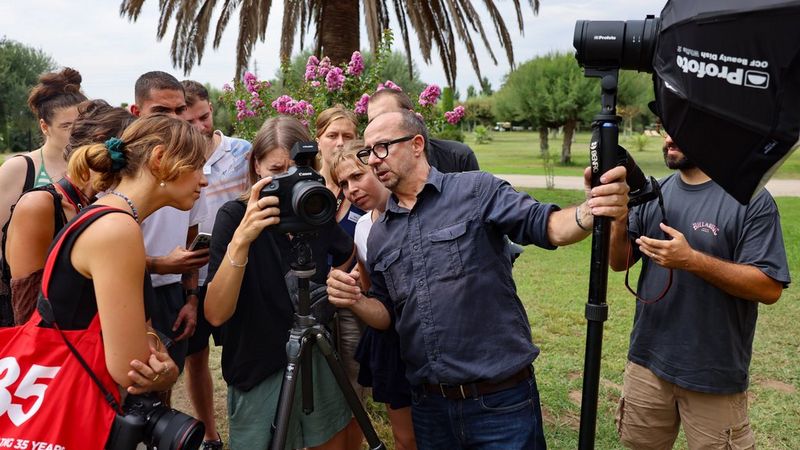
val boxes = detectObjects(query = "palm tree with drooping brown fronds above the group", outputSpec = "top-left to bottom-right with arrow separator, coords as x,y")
120,0 -> 539,86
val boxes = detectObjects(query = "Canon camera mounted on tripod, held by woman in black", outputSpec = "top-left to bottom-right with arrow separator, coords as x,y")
259,142 -> 336,233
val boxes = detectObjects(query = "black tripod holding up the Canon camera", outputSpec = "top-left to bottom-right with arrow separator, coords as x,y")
270,233 -> 386,450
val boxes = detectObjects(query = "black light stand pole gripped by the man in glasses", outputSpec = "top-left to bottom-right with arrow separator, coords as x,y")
578,69 -> 620,450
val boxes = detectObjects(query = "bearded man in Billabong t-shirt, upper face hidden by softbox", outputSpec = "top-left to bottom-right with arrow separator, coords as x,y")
610,136 -> 790,449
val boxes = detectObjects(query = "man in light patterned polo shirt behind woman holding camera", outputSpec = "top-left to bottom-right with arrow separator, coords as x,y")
181,80 -> 250,450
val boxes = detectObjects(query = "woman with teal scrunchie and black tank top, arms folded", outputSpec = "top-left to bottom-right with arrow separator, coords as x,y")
38,115 -> 207,394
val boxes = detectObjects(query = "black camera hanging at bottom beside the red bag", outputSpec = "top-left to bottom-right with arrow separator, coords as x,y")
106,394 -> 206,450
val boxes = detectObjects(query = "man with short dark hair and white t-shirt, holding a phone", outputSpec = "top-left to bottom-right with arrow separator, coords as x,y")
131,71 -> 208,371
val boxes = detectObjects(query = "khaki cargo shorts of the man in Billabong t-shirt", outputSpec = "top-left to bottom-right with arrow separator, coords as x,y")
616,362 -> 755,449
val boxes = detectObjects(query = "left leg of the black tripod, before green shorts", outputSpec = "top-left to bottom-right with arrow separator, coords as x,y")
270,330 -> 304,450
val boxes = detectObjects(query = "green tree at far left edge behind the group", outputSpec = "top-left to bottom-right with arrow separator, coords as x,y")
0,38 -> 56,151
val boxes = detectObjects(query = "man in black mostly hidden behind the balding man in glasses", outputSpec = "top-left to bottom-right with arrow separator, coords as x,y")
367,88 -> 480,173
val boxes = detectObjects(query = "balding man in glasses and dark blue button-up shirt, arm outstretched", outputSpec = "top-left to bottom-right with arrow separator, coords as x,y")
328,111 -> 628,449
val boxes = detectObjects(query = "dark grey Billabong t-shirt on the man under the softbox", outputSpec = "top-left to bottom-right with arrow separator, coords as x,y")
628,173 -> 790,394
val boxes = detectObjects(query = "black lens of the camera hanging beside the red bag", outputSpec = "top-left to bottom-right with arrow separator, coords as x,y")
146,407 -> 205,450
